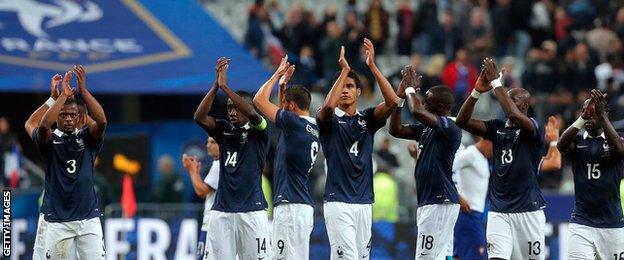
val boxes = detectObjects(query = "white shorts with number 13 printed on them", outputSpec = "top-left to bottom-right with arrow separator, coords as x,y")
486,210 -> 546,260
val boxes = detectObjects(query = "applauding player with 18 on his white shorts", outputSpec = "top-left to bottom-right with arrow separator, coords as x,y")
390,65 -> 462,259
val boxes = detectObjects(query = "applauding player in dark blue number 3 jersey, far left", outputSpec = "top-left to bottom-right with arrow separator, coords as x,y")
26,66 -> 106,259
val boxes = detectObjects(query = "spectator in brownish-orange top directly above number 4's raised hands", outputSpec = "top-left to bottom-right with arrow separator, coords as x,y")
365,0 -> 390,55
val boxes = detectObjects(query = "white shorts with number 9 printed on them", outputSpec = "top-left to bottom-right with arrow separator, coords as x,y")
272,203 -> 314,259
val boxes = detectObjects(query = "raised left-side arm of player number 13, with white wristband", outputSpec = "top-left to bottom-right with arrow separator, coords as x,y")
455,71 -> 492,136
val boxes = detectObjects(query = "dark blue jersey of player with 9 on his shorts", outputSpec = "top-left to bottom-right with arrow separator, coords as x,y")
273,109 -> 320,205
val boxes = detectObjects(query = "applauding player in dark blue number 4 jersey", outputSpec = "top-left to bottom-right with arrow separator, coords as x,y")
317,39 -> 398,259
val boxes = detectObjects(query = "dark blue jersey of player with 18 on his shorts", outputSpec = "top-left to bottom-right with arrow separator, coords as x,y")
410,117 -> 462,207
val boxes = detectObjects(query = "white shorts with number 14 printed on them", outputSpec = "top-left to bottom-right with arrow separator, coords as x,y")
204,210 -> 271,260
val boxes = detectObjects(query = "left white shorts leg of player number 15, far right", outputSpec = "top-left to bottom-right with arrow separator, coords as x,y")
568,223 -> 596,260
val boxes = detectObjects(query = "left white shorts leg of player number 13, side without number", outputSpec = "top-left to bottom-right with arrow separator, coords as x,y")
485,212 -> 514,259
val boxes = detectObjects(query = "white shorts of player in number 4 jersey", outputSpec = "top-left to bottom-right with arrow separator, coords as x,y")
323,201 -> 373,259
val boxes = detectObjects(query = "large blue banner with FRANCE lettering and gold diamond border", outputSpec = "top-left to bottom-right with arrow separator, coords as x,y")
0,0 -> 269,94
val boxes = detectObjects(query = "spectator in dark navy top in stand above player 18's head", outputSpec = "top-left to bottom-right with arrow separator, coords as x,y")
431,10 -> 464,61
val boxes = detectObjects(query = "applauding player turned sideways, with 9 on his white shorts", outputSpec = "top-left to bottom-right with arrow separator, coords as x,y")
254,56 -> 320,259
